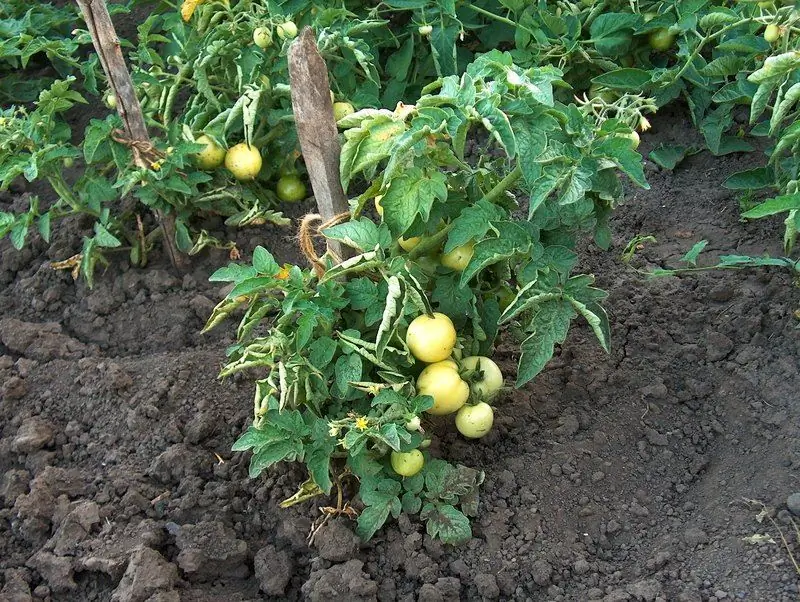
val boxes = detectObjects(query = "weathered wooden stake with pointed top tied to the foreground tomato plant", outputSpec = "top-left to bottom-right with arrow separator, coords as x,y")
289,27 -> 350,259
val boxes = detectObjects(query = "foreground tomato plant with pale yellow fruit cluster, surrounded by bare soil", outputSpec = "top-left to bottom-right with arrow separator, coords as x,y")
207,51 -> 647,543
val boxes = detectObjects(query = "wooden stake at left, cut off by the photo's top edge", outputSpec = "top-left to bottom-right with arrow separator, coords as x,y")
76,0 -> 188,270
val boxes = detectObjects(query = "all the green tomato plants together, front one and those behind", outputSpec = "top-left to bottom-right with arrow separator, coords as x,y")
0,0 -> 798,543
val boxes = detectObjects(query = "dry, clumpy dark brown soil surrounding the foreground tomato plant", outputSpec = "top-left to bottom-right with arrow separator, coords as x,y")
0,115 -> 800,602
